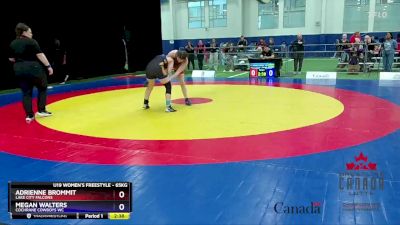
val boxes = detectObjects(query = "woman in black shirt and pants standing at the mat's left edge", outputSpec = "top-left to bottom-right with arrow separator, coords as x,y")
9,23 -> 53,123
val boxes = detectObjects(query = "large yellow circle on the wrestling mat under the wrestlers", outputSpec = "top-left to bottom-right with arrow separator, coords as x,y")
38,85 -> 344,140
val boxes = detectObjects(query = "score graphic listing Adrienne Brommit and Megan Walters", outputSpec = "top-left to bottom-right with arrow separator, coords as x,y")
8,182 -> 132,219
